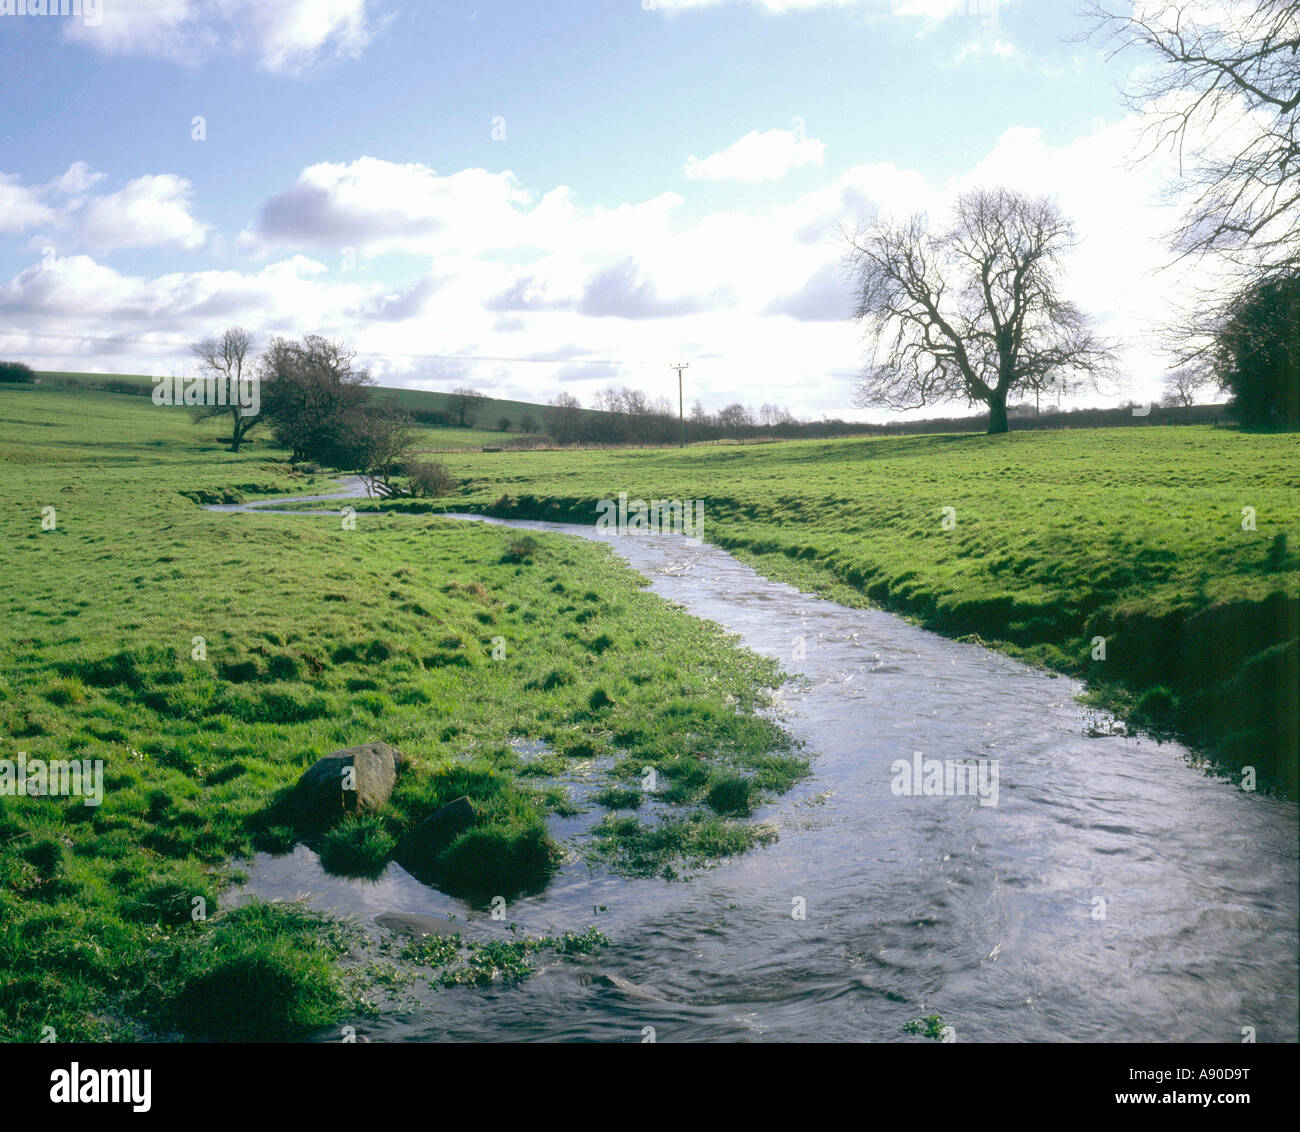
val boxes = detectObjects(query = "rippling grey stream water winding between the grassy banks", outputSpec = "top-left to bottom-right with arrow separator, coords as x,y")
224,485 -> 1300,1042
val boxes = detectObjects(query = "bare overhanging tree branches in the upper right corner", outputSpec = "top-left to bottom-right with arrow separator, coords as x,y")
1089,0 -> 1300,277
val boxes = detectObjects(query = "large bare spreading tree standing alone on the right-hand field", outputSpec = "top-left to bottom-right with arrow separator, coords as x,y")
845,188 -> 1113,433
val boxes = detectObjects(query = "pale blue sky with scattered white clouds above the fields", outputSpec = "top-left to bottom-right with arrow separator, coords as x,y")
0,0 -> 1227,420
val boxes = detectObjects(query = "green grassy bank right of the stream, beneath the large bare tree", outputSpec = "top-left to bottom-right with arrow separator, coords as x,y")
408,426 -> 1300,797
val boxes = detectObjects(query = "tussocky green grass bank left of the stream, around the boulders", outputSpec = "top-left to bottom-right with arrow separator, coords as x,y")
0,389 -> 806,1041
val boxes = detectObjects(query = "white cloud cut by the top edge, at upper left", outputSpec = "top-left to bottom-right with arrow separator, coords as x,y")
64,0 -> 376,74
